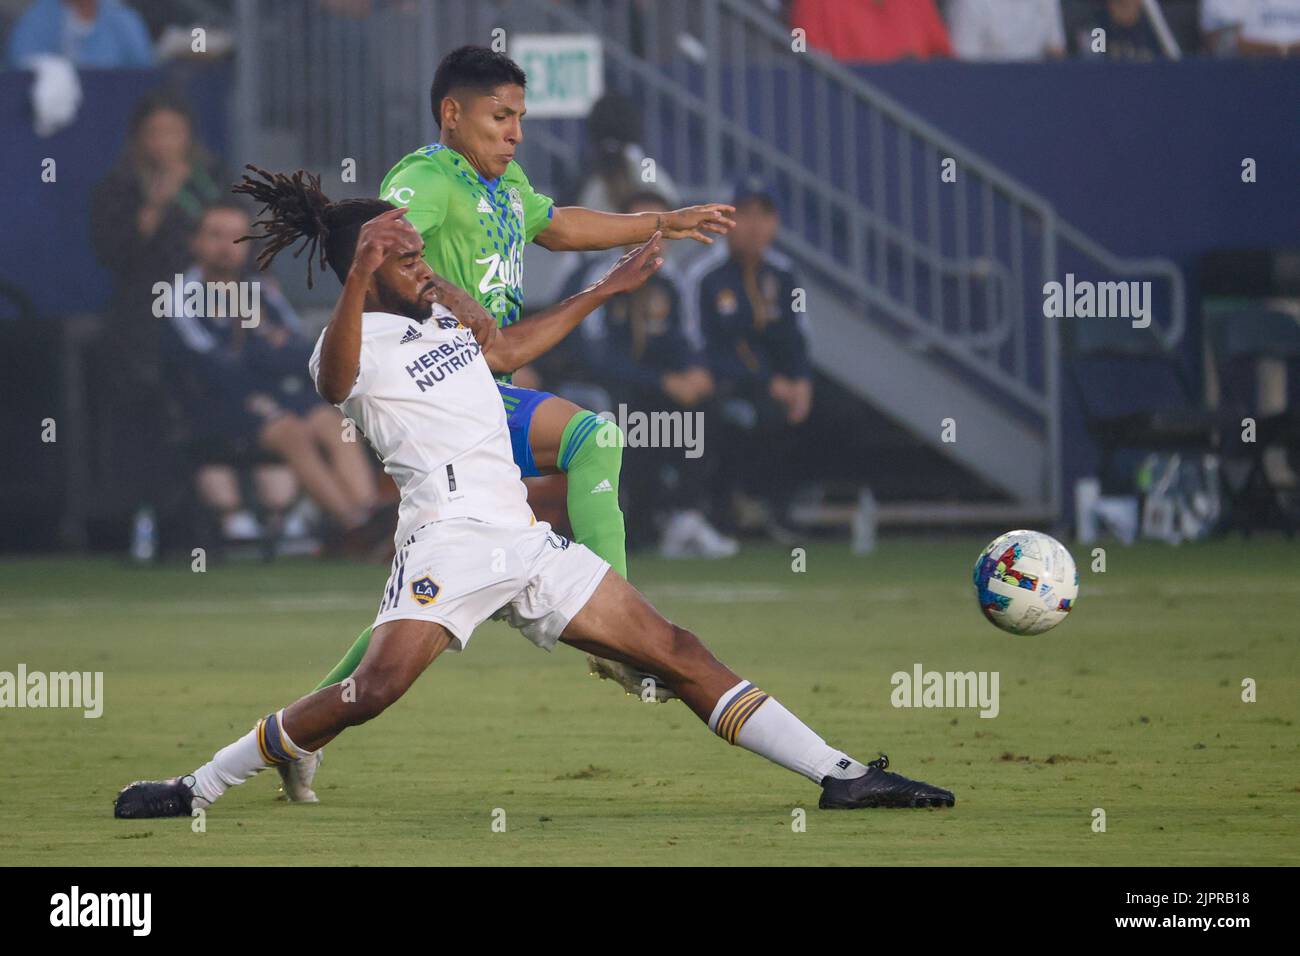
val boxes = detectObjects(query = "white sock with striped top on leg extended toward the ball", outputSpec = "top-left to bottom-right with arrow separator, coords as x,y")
709,680 -> 867,783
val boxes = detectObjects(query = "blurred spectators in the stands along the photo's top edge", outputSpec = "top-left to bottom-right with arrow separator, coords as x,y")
0,0 -> 1300,68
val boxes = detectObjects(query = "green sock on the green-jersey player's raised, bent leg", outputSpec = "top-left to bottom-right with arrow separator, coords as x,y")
558,411 -> 628,578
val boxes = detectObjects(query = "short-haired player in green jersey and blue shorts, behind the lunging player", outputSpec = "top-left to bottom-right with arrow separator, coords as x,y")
297,47 -> 735,780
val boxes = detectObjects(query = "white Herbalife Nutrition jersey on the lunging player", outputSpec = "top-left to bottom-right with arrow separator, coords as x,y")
308,304 -> 534,546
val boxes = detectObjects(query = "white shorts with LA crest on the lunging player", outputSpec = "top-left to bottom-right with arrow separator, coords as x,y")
374,518 -> 610,650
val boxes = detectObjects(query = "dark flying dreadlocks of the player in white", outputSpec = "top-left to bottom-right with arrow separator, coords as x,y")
230,164 -> 394,289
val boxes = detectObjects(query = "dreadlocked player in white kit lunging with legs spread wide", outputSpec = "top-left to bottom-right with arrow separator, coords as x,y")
114,172 -> 954,818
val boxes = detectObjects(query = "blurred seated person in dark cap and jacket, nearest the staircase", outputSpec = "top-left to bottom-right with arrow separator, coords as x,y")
684,177 -> 813,544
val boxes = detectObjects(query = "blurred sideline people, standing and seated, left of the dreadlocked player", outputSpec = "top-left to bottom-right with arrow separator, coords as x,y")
80,85 -> 385,553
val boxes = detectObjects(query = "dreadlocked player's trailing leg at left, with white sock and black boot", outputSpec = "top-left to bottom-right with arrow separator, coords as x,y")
114,619 -> 451,818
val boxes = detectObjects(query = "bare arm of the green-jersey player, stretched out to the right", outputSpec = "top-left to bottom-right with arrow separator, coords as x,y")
534,203 -> 736,252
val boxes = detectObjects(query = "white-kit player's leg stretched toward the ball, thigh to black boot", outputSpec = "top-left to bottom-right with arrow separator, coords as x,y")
560,574 -> 954,808
